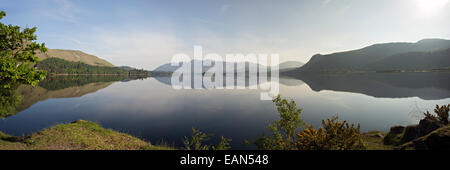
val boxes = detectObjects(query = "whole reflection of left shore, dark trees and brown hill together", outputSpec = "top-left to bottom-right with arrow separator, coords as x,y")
0,75 -> 147,117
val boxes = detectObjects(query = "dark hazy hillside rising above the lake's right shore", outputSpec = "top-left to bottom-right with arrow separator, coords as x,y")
293,39 -> 450,72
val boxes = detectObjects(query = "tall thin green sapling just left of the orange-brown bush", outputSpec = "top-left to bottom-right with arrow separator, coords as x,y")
255,95 -> 305,150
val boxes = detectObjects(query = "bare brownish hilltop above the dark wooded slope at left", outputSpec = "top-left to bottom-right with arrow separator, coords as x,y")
37,49 -> 114,67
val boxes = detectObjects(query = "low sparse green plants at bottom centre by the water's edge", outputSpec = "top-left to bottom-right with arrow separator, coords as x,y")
183,128 -> 231,150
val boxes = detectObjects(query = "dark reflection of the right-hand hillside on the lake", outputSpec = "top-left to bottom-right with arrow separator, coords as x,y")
298,72 -> 450,100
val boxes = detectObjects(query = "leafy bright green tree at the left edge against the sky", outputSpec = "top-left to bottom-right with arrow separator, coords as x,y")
0,11 -> 47,88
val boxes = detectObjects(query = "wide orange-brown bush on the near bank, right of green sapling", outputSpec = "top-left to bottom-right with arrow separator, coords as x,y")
295,116 -> 364,150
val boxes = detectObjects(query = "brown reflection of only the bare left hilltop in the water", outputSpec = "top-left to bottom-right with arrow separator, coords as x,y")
16,82 -> 113,112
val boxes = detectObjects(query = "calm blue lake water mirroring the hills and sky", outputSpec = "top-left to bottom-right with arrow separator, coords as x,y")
0,73 -> 450,149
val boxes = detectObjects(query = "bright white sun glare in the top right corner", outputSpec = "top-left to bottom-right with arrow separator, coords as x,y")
416,0 -> 449,17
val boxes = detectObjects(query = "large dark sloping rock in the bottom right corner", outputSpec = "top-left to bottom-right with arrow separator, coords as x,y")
400,126 -> 450,150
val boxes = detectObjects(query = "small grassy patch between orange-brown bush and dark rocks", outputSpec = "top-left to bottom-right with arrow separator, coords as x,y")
361,131 -> 393,150
